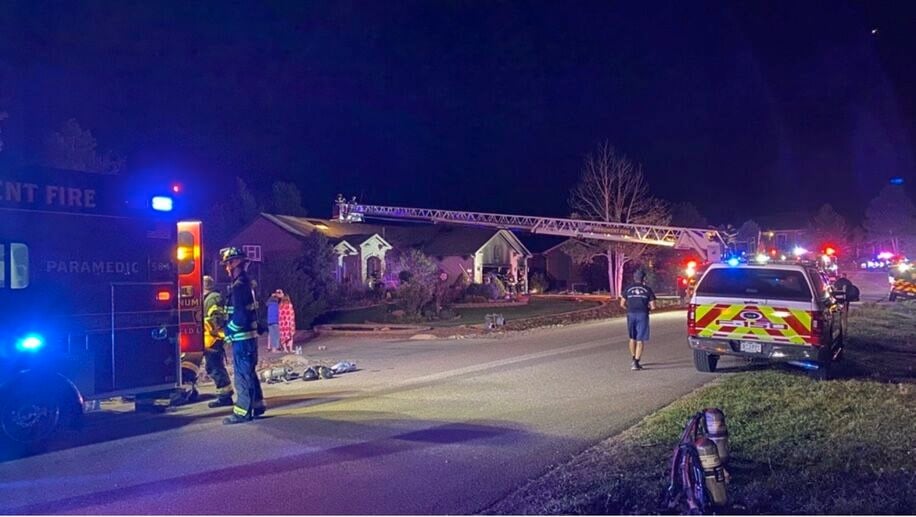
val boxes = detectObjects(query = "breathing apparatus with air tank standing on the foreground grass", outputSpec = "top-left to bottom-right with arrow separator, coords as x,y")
664,408 -> 729,515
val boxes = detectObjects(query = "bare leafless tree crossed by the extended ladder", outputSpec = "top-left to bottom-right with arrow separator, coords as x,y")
569,142 -> 671,296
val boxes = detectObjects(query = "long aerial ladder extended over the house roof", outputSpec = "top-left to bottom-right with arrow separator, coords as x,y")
335,196 -> 728,262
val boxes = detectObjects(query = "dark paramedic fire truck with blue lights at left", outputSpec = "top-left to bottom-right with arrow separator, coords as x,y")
0,168 -> 203,446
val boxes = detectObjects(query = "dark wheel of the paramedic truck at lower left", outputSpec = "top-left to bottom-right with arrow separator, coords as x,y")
0,387 -> 63,449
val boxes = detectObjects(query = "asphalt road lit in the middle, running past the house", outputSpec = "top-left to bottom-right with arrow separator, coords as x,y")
0,312 -> 739,514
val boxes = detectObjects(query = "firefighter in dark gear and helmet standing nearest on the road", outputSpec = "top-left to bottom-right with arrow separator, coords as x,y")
219,247 -> 266,425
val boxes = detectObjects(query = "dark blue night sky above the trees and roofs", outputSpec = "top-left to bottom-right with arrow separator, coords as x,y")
0,1 -> 916,222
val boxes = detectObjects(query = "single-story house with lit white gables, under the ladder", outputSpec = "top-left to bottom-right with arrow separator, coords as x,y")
227,213 -> 531,293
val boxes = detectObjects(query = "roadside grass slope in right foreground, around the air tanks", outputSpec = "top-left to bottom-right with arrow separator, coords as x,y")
486,304 -> 916,514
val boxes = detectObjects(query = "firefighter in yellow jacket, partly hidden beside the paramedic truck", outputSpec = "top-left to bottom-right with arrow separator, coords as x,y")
204,276 -> 232,408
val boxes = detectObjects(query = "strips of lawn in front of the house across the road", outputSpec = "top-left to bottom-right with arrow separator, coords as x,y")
315,298 -> 600,327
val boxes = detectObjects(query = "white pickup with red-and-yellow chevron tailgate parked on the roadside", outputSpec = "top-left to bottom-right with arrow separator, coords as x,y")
687,260 -> 843,379
